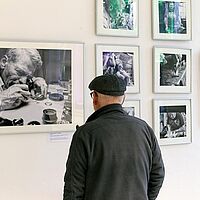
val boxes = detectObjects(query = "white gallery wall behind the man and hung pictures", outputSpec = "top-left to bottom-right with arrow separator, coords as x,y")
0,0 -> 200,200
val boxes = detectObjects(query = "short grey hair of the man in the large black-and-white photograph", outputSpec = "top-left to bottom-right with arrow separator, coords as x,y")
6,48 -> 42,69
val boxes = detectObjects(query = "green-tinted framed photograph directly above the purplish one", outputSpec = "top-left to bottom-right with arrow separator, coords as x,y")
96,0 -> 139,37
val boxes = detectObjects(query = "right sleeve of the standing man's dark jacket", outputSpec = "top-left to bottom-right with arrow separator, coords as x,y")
148,127 -> 165,200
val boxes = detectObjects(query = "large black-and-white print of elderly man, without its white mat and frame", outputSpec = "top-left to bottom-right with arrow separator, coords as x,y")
0,48 -> 72,126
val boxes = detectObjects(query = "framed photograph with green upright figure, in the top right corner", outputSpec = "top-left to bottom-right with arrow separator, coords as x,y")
152,0 -> 192,40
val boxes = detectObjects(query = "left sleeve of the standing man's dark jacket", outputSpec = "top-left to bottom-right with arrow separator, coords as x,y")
63,129 -> 87,200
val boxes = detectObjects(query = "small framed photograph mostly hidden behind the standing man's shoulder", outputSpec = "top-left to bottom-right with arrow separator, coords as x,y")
122,100 -> 141,118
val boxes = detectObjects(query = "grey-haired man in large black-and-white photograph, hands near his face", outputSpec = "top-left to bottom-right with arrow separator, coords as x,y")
0,48 -> 47,110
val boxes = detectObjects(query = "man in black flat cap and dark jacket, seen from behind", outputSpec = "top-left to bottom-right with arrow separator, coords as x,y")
63,75 -> 164,200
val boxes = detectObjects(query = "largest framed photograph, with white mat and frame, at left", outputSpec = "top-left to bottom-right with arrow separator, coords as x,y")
0,42 -> 83,134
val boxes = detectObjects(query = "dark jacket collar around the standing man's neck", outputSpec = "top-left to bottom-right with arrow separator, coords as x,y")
86,104 -> 124,123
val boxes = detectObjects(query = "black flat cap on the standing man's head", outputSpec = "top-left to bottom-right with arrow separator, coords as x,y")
88,74 -> 126,96
